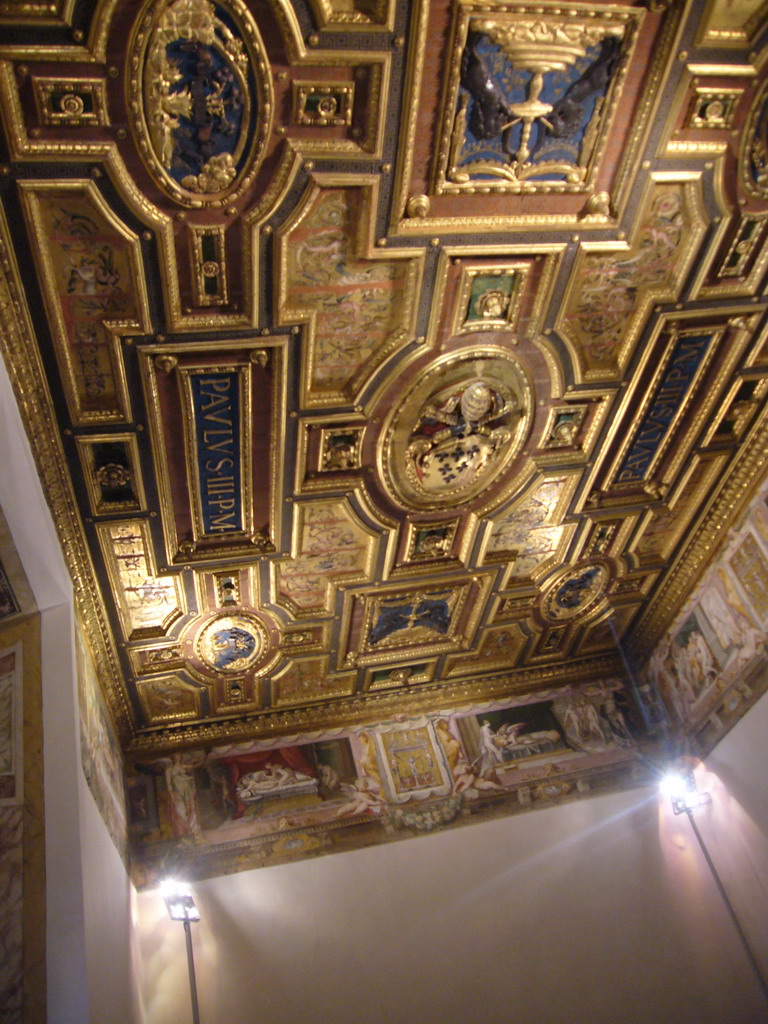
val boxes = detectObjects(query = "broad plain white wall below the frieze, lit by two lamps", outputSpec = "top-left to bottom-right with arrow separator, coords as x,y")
138,706 -> 768,1024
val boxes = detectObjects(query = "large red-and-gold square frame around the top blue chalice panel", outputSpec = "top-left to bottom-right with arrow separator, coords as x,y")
390,0 -> 686,234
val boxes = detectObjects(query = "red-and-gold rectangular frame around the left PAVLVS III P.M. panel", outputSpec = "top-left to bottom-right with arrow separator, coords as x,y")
140,336 -> 288,565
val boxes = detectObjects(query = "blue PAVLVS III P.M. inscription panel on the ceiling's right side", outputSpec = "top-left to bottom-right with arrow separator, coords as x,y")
616,334 -> 712,483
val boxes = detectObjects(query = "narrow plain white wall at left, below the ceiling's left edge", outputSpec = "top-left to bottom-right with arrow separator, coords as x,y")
0,359 -> 142,1024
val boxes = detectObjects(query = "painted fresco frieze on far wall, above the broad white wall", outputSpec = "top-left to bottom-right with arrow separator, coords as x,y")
128,679 -> 636,884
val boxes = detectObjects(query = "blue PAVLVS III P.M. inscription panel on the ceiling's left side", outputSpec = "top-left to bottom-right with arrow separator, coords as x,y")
189,372 -> 243,534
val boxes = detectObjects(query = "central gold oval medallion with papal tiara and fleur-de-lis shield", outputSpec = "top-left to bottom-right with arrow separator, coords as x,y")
381,348 -> 534,509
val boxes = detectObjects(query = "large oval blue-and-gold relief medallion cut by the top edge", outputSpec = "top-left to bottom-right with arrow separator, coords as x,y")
129,0 -> 272,206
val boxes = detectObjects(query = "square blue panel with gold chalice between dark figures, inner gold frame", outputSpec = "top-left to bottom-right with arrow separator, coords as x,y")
438,8 -> 632,190
